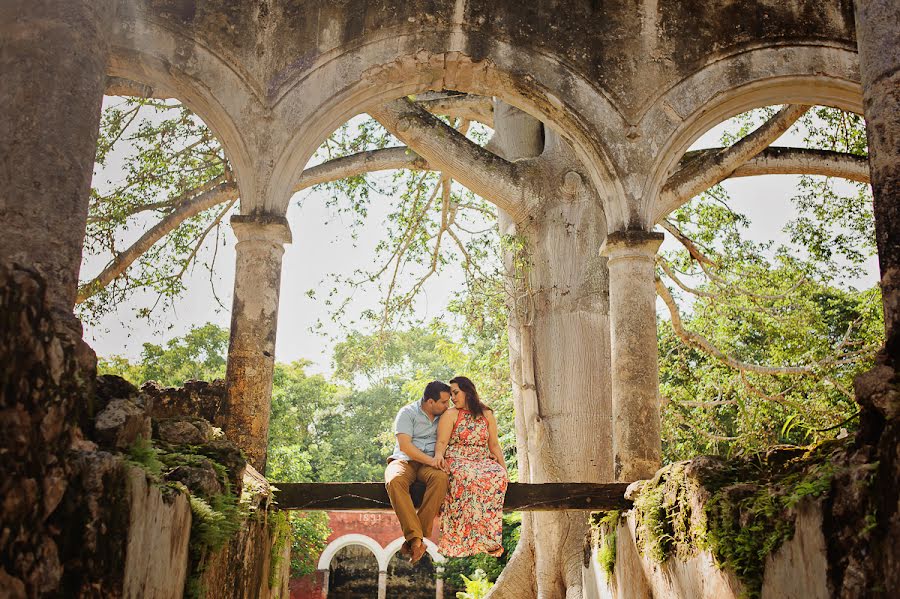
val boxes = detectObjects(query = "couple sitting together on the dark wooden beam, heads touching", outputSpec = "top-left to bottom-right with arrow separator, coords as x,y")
384,376 -> 509,563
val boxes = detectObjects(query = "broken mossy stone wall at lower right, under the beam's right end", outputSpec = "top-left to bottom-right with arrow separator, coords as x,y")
584,365 -> 900,599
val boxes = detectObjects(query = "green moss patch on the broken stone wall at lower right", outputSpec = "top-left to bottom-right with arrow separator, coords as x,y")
634,443 -> 848,598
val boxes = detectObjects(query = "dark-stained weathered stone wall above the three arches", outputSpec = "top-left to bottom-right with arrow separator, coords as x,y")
122,0 -> 855,112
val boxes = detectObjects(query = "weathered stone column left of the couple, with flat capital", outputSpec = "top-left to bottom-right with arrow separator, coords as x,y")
224,215 -> 291,474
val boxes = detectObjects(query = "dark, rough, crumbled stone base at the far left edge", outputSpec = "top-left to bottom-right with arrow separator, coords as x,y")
0,264 -> 96,597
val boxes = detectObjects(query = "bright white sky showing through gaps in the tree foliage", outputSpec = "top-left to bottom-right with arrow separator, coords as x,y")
82,103 -> 878,374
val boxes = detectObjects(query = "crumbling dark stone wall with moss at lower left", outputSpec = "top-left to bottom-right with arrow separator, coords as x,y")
0,264 -> 290,599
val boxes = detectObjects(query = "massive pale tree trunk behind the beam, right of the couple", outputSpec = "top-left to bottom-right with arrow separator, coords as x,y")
491,106 -> 612,599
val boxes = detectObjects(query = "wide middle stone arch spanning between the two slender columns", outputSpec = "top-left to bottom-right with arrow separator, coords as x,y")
267,32 -> 628,230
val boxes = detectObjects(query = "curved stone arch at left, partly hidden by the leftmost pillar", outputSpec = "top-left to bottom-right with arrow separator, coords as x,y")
107,12 -> 261,211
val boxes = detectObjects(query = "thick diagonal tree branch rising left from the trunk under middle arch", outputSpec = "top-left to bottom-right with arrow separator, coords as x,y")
368,98 -> 541,222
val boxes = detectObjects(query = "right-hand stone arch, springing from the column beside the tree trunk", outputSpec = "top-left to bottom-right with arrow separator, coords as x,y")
640,45 -> 862,229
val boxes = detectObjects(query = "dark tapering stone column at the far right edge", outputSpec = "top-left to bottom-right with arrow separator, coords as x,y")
854,0 -> 900,360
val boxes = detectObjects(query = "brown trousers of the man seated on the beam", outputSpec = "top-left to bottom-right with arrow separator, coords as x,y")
384,460 -> 450,541
